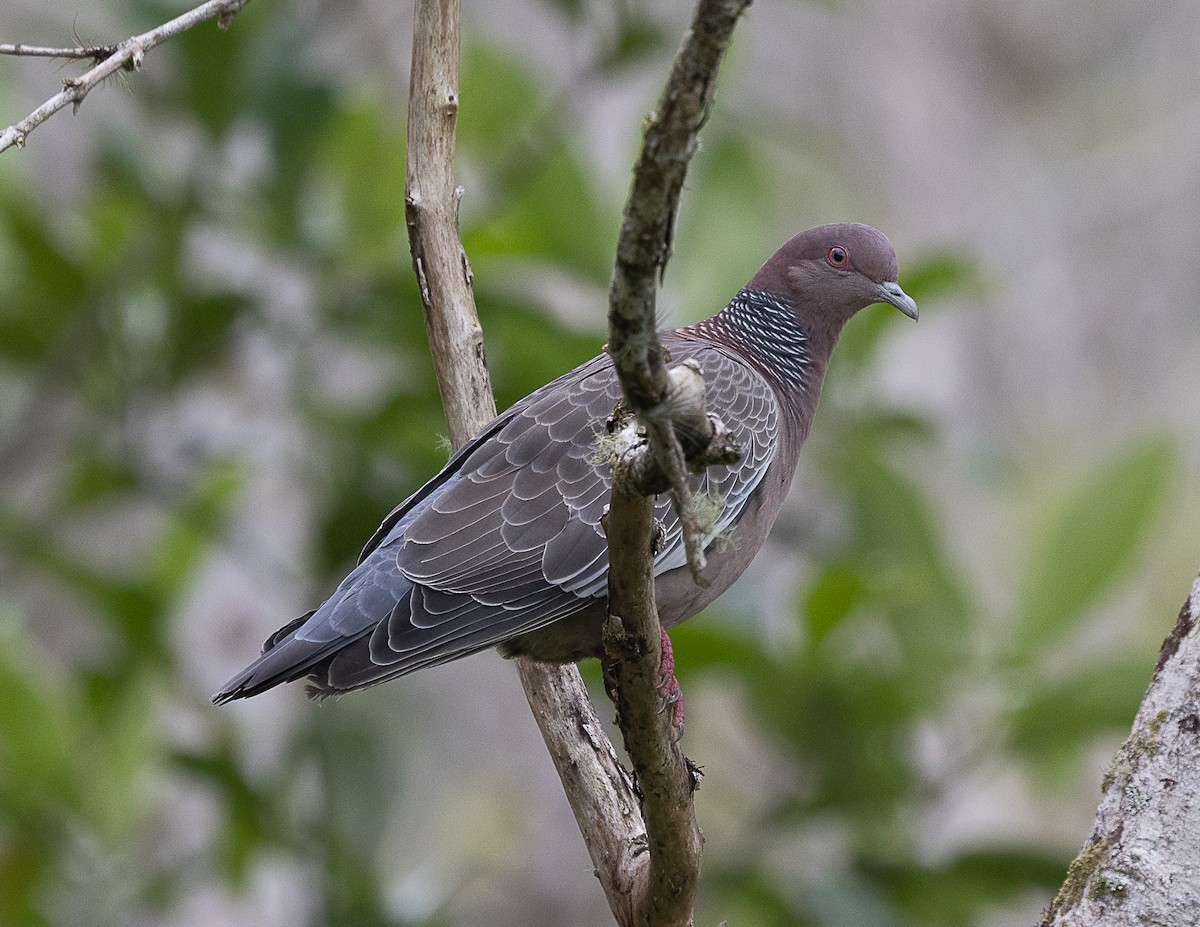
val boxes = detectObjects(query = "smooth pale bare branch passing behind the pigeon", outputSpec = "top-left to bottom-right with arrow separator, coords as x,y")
406,0 -> 647,926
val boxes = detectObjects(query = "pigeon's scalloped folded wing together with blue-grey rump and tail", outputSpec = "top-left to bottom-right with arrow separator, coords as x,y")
218,333 -> 780,699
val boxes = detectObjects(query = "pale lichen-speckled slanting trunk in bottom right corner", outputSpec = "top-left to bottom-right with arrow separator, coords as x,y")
1040,569 -> 1200,927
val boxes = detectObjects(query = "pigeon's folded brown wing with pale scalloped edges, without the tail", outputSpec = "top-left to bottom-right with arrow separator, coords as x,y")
343,336 -> 779,671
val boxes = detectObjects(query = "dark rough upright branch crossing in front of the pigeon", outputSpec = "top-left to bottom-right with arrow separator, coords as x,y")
605,0 -> 749,927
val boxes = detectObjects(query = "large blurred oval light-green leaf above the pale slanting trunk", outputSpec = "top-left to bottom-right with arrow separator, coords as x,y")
1014,437 -> 1178,653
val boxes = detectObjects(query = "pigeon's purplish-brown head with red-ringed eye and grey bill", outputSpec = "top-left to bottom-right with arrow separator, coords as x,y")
748,222 -> 917,331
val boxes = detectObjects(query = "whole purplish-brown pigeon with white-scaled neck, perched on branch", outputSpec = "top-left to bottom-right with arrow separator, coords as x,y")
214,223 -> 917,704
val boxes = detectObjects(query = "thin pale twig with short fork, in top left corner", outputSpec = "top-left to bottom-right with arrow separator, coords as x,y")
0,0 -> 250,151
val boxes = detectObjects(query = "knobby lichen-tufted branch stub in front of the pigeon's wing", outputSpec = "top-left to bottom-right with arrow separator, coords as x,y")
595,359 -> 743,586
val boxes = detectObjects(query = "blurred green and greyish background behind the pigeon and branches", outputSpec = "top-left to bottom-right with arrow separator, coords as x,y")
0,0 -> 1200,927
